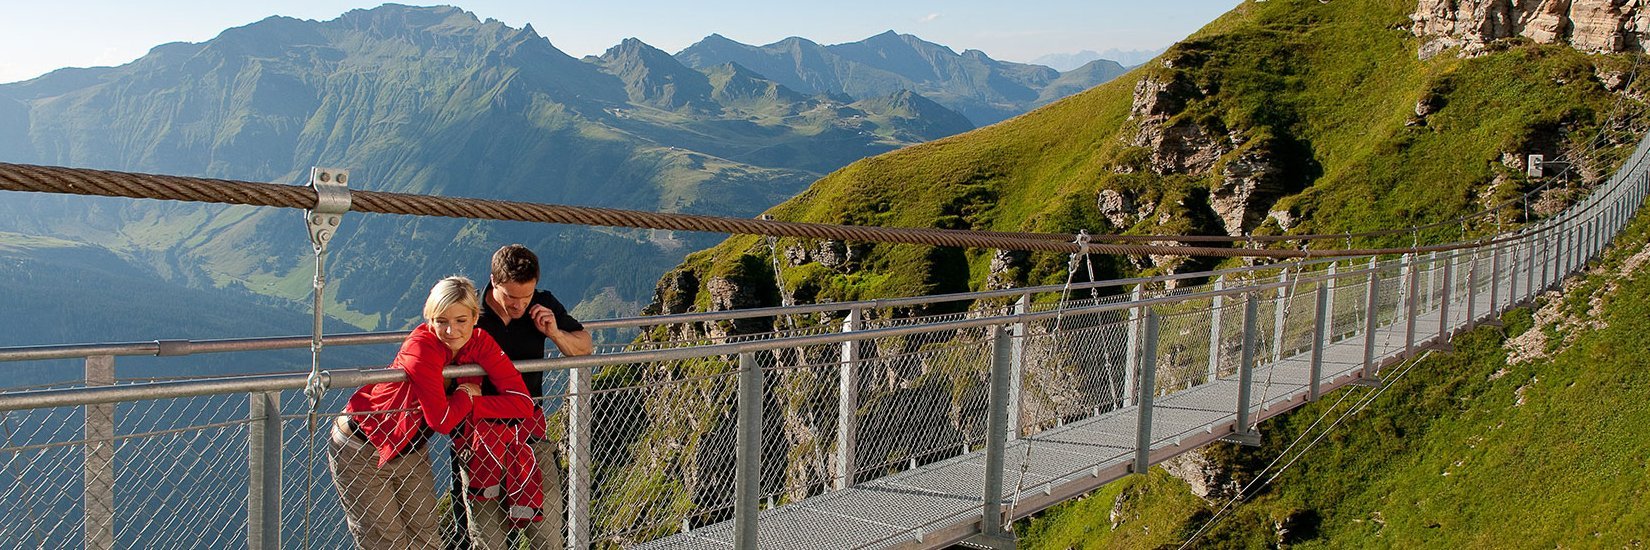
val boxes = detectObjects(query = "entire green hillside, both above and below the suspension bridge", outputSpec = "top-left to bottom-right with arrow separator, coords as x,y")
617,0 -> 1650,548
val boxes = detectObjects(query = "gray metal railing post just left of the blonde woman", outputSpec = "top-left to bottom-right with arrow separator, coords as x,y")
246,391 -> 285,550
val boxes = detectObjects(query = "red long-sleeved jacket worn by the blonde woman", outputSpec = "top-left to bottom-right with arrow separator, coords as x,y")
343,325 -> 533,467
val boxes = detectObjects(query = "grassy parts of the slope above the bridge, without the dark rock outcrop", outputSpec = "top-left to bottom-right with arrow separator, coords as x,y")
663,0 -> 1638,308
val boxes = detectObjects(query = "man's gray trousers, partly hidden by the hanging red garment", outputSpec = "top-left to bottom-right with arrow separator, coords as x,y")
464,441 -> 568,550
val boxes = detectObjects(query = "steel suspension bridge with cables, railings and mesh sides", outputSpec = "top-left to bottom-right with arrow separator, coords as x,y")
0,126 -> 1650,548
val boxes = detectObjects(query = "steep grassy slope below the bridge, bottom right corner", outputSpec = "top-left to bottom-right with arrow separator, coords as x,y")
1021,199 -> 1650,548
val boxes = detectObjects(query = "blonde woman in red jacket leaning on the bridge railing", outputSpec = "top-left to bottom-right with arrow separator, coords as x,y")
327,277 -> 533,548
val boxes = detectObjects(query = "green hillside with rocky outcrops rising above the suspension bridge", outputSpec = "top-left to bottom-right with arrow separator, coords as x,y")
655,0 -> 1647,315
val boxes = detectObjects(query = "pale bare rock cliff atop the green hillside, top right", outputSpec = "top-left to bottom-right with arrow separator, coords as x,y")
1411,0 -> 1650,59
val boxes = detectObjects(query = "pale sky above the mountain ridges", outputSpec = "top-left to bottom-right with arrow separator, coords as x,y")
0,0 -> 1241,83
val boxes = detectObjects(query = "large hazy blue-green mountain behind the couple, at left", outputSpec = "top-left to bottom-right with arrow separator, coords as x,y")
0,5 -> 972,345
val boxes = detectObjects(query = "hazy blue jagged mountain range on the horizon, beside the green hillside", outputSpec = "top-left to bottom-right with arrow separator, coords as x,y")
677,31 -> 1122,126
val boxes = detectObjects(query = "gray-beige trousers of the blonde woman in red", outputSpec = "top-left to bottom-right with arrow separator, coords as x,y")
327,418 -> 441,550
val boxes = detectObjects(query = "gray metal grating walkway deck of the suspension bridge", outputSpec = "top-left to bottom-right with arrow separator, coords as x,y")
639,289 -> 1506,548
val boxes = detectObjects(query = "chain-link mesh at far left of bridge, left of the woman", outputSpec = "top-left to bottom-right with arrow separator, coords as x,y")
0,395 -> 248,548
